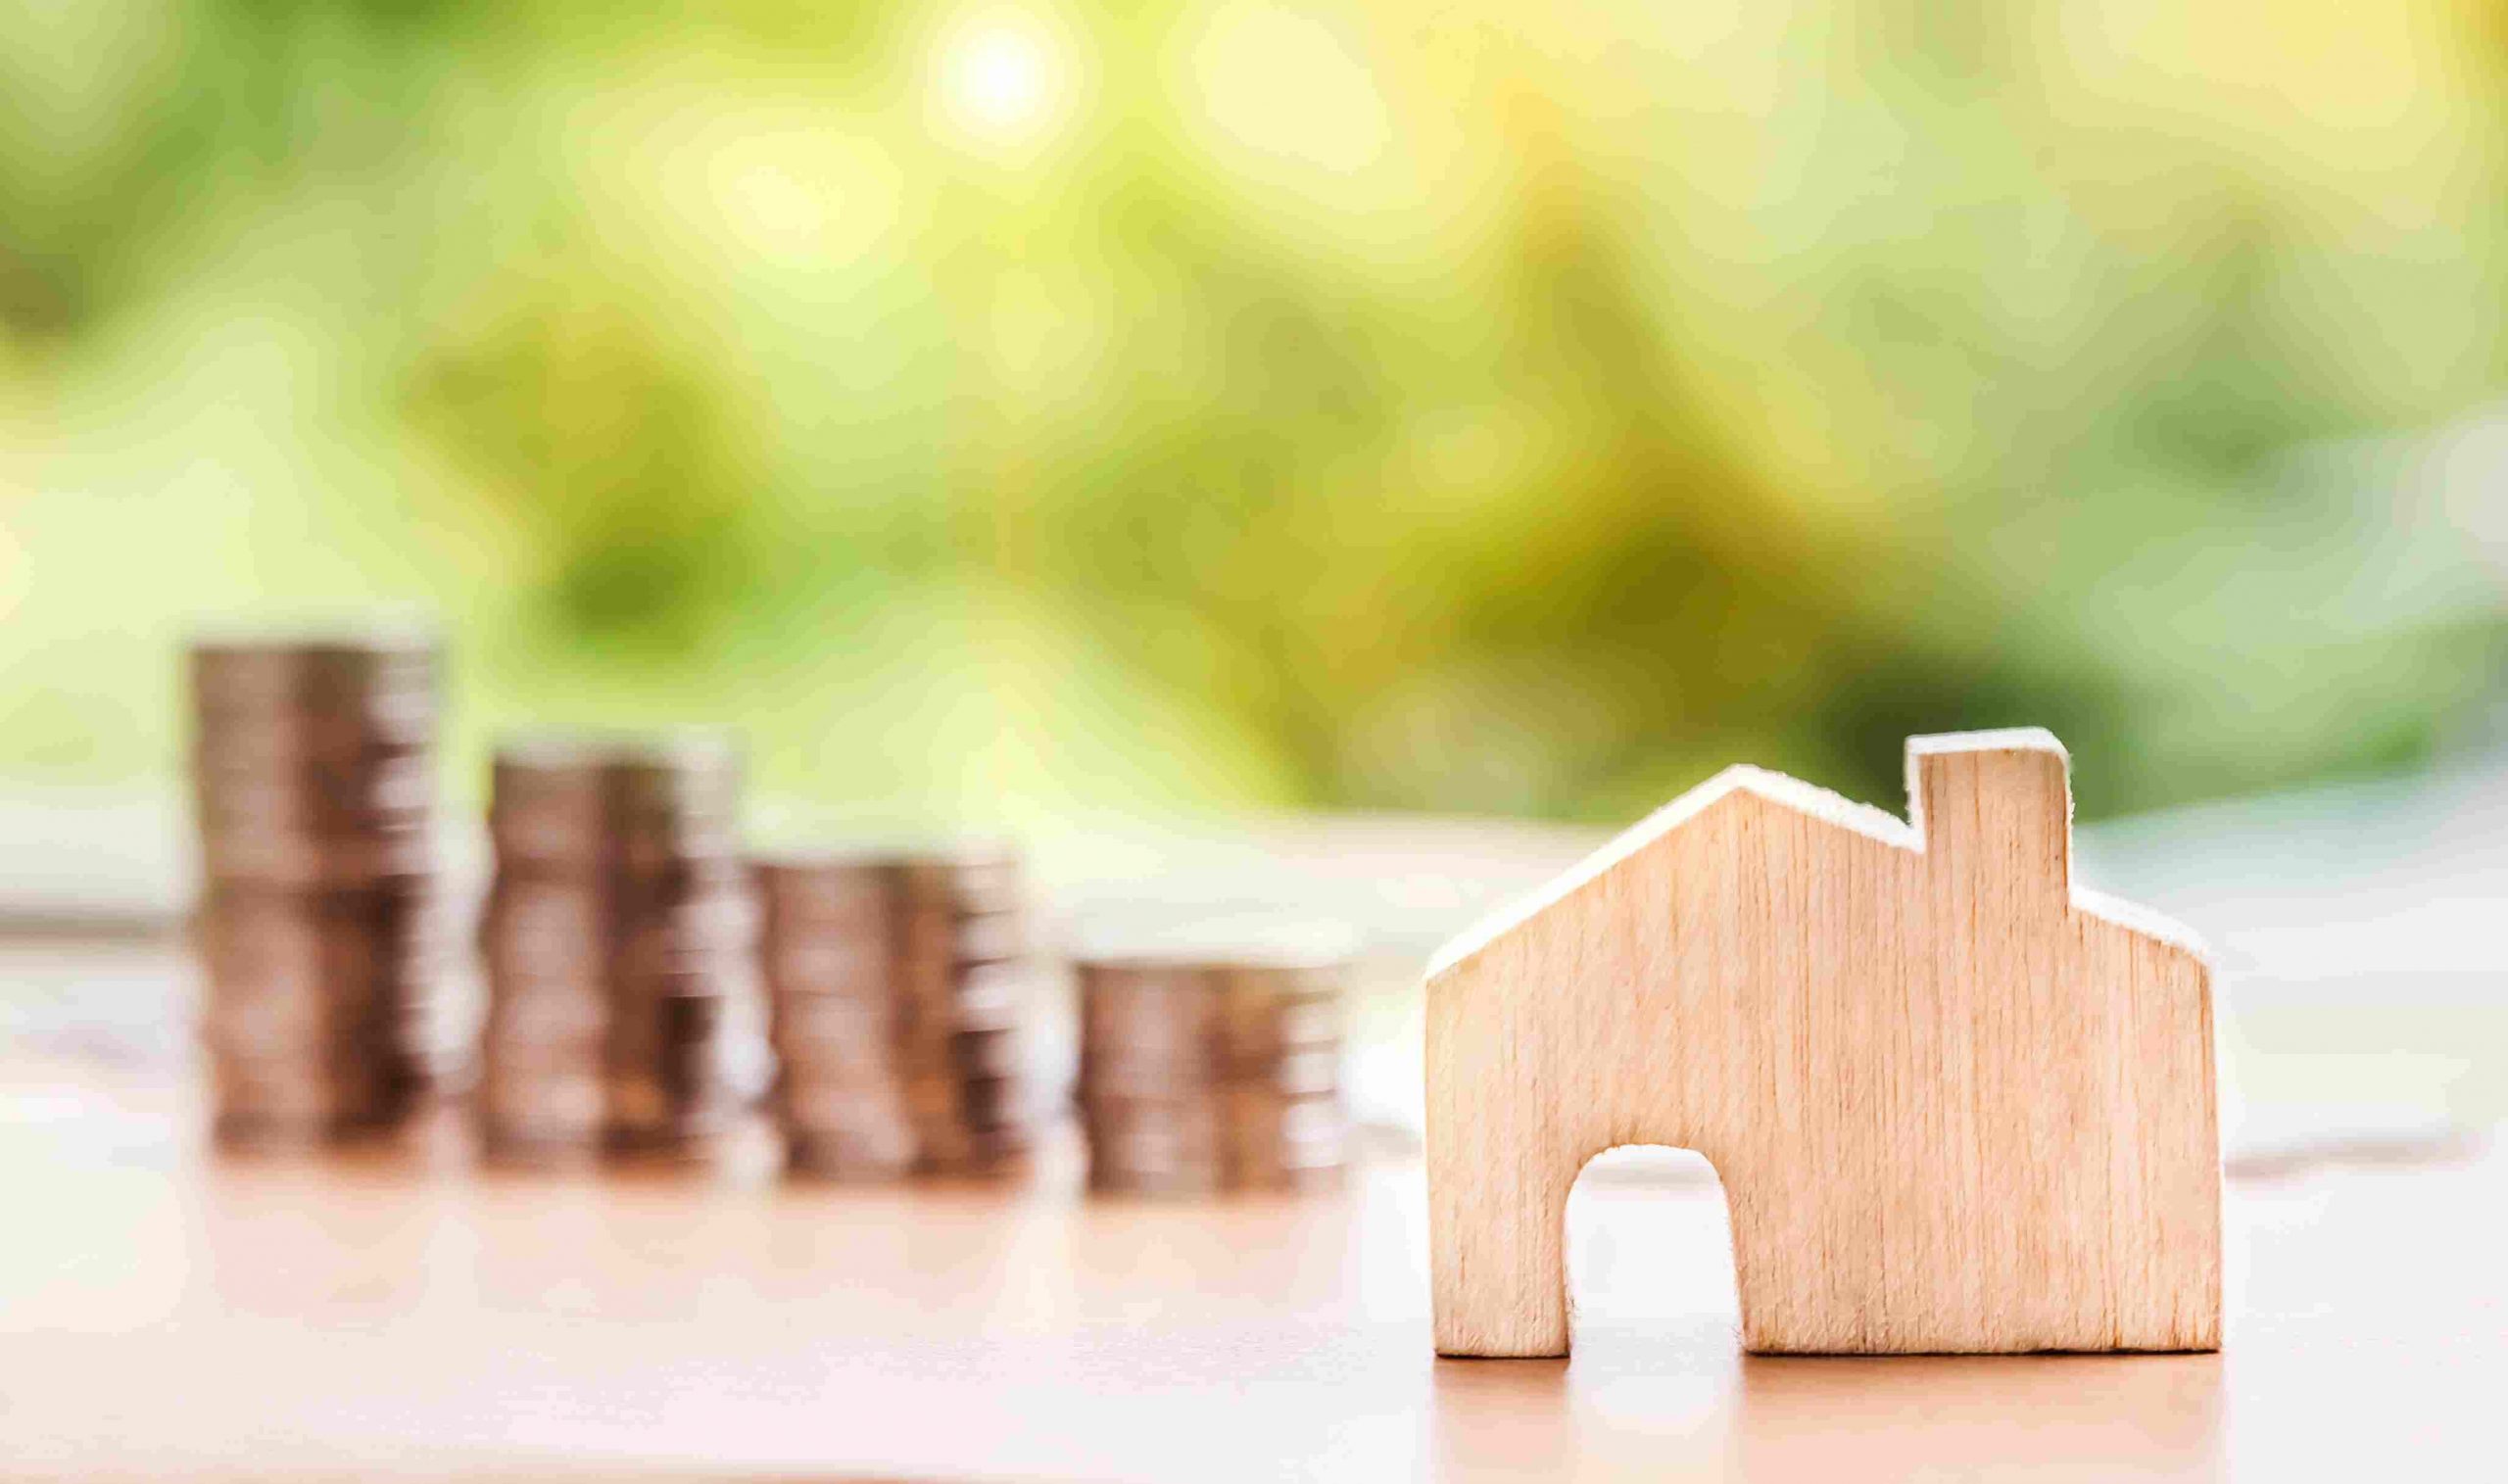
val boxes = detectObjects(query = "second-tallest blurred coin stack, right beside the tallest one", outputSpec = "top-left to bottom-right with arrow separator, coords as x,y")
482,735 -> 765,1161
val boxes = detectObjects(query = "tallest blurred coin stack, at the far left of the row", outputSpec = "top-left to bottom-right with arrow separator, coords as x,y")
191,634 -> 469,1143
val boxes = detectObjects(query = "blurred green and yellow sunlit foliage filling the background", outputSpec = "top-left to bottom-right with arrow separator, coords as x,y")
0,0 -> 2508,822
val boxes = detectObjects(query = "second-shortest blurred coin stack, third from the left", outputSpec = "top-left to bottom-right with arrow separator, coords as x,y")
757,842 -> 1031,1175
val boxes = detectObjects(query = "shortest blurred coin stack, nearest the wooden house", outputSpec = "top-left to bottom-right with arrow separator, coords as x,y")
1079,935 -> 1349,1193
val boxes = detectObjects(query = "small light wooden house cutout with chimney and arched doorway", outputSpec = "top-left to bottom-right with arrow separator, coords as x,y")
1427,730 -> 2220,1356
